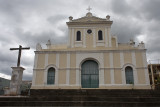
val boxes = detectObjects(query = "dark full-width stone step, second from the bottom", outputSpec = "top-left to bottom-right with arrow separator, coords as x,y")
0,96 -> 160,102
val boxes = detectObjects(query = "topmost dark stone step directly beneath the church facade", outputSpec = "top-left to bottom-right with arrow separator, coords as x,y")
30,89 -> 160,95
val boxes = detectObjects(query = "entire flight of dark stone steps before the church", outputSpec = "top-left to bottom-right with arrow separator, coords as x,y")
0,89 -> 160,107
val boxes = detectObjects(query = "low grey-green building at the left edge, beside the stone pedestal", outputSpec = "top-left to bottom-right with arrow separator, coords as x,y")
0,77 -> 10,95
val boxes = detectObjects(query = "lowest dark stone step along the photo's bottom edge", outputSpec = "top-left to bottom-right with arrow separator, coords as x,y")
0,101 -> 160,107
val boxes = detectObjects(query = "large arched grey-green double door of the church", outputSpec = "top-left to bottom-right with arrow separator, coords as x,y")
81,60 -> 99,88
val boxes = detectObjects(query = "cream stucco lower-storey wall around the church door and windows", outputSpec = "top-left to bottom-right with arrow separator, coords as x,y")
31,51 -> 148,89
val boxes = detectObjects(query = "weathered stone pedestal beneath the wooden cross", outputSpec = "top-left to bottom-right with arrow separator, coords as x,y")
10,67 -> 25,95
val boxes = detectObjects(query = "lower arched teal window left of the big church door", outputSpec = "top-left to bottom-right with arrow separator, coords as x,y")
47,67 -> 55,84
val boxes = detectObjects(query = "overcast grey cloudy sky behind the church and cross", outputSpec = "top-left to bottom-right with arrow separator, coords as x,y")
0,0 -> 160,80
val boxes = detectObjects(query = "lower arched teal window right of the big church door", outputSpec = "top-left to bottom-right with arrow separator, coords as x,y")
125,66 -> 134,84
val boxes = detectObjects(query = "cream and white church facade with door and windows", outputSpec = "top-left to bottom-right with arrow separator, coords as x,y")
31,12 -> 150,89
